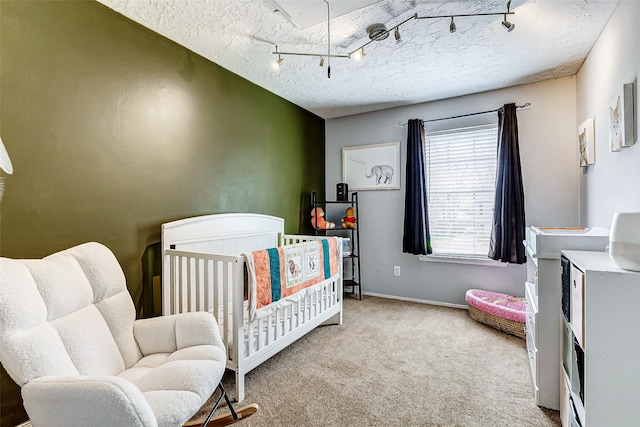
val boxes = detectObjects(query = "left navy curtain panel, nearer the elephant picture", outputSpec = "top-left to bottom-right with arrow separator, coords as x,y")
402,119 -> 432,255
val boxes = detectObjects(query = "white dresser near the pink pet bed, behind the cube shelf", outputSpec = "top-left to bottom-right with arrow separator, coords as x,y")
524,227 -> 609,410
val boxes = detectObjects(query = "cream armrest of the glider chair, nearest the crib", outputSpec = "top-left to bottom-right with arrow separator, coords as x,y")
133,311 -> 224,356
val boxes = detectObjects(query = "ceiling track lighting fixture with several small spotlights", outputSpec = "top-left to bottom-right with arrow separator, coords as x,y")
272,0 -> 515,77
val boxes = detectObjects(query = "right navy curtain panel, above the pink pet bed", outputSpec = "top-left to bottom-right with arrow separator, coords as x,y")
489,104 -> 527,264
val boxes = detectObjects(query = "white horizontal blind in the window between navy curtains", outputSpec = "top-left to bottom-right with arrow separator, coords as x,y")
425,124 -> 498,258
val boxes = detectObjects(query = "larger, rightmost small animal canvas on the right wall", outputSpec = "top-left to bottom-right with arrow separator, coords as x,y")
609,83 -> 636,151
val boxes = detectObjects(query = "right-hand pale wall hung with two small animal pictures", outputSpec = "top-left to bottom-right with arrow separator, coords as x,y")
576,0 -> 640,227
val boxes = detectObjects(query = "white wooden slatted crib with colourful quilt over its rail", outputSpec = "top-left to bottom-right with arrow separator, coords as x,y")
162,214 -> 342,402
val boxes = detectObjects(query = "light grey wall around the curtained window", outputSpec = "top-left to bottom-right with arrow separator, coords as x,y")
326,76 -> 578,304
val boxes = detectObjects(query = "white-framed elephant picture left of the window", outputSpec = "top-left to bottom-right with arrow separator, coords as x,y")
342,141 -> 400,191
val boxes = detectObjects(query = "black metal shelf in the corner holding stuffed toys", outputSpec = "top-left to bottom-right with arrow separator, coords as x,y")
311,191 -> 362,300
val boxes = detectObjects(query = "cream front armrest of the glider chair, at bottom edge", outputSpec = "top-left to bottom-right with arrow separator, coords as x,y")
22,375 -> 158,427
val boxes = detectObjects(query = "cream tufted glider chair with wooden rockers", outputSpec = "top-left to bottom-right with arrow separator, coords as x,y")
0,243 -> 257,427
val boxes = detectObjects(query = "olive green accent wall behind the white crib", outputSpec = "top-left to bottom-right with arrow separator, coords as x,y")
0,0 -> 325,299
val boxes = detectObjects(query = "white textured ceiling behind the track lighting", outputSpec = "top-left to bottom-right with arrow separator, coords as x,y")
99,0 -> 618,119
